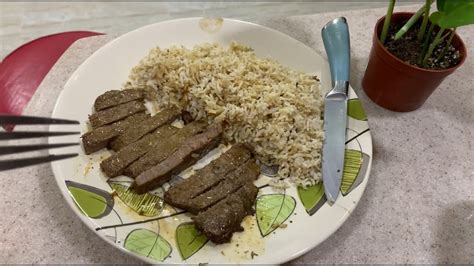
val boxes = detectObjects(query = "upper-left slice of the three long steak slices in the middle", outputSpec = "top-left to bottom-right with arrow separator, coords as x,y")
100,125 -> 179,178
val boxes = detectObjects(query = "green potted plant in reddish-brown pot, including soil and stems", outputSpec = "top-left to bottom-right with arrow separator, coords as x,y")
362,0 -> 474,112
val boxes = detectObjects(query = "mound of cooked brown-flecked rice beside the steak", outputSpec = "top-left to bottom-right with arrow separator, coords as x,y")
125,43 -> 323,186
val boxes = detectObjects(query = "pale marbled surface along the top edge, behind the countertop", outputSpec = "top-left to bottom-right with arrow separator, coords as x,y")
0,0 -> 410,59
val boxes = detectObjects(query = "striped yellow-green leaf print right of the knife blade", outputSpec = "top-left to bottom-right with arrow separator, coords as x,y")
341,149 -> 363,196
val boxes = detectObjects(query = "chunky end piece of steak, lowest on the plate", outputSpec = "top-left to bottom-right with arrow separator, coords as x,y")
192,183 -> 258,244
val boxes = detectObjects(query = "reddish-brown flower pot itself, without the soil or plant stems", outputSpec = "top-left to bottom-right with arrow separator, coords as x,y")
362,12 -> 467,112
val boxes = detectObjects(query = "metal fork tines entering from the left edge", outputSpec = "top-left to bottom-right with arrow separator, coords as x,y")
0,115 -> 80,171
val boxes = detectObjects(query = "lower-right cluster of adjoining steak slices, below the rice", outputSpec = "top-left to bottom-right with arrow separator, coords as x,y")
165,144 -> 260,244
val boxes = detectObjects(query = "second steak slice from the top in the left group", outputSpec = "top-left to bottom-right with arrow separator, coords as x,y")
89,101 -> 146,129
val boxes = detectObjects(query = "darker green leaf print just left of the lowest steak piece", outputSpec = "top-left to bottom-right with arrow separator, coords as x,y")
176,223 -> 208,260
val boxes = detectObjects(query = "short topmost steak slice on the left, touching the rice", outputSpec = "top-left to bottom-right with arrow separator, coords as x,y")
94,90 -> 145,112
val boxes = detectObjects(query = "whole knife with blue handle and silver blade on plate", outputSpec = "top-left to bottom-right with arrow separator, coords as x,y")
321,17 -> 350,204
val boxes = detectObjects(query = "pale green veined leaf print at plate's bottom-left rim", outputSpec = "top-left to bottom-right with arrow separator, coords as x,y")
123,229 -> 171,261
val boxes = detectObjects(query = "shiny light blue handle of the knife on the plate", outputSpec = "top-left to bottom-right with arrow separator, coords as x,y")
321,17 -> 351,93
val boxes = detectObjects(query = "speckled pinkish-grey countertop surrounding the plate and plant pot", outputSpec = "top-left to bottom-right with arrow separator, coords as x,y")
0,5 -> 474,264
